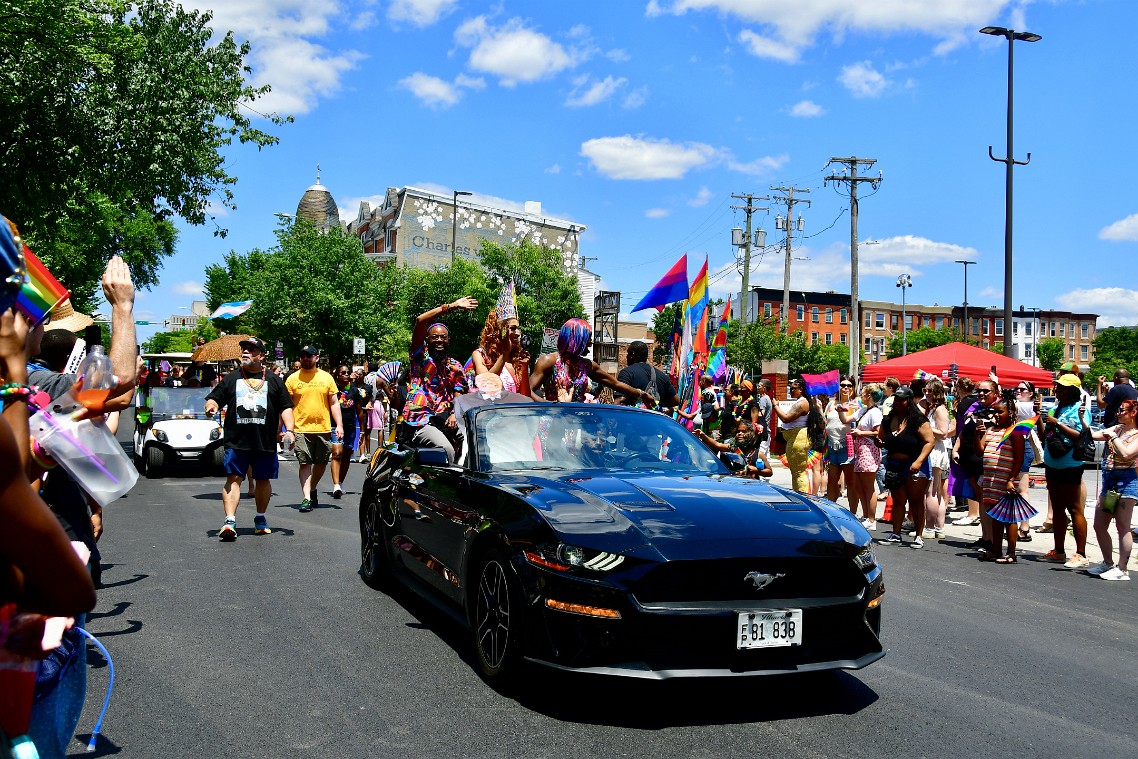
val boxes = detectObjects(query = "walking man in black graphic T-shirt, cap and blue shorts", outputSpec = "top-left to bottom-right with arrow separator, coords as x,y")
206,337 -> 296,541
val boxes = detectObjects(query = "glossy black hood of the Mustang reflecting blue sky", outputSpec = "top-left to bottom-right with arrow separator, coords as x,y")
500,473 -> 869,559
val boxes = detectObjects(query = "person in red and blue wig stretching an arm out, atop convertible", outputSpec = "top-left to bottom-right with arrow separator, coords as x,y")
529,319 -> 654,406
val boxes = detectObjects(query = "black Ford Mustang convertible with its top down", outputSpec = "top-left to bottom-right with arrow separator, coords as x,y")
360,403 -> 885,680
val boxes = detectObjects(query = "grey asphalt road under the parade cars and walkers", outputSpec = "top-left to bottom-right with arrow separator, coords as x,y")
73,462 -> 1138,759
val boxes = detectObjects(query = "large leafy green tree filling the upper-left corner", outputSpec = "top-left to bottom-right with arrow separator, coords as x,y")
0,0 -> 288,310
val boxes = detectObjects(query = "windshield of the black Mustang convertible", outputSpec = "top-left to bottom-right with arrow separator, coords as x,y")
471,403 -> 727,473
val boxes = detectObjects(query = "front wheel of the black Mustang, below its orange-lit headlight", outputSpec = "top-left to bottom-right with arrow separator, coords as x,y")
470,551 -> 525,686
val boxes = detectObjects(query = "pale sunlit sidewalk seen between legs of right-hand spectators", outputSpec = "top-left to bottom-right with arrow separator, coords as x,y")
770,459 -> 1119,566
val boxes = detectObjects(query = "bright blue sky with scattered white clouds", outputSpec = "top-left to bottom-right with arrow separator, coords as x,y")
124,0 -> 1138,337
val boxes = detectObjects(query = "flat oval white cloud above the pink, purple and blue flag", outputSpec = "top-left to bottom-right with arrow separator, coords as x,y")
580,134 -> 718,180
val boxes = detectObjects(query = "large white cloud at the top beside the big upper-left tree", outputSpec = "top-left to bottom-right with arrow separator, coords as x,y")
182,0 -> 366,115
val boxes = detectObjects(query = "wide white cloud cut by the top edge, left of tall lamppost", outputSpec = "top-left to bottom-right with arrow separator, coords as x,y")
644,0 -> 1026,63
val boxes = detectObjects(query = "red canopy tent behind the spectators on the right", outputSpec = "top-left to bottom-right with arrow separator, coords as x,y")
861,343 -> 1054,388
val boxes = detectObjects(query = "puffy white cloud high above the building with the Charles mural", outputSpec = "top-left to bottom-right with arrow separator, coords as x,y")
454,16 -> 578,86
